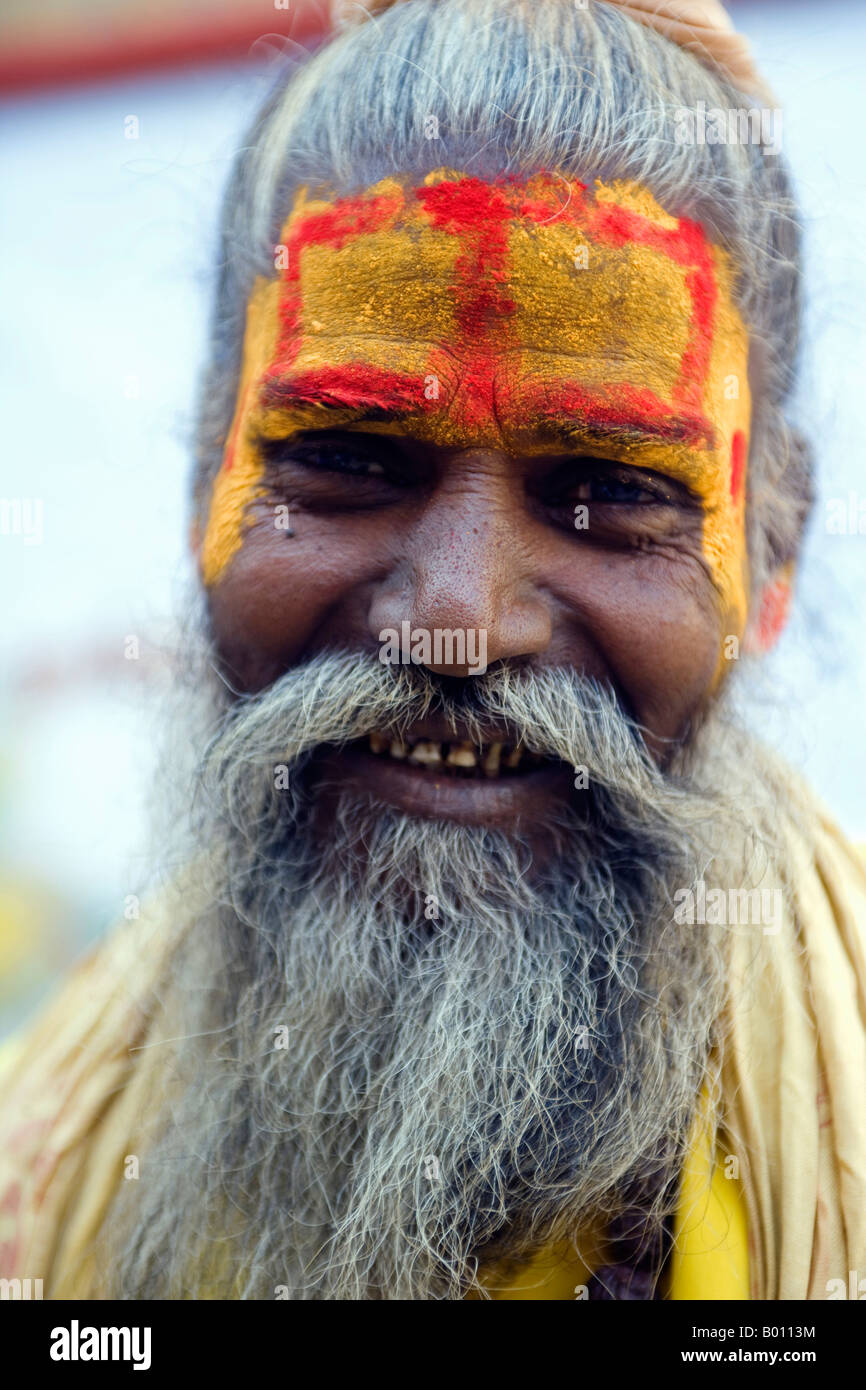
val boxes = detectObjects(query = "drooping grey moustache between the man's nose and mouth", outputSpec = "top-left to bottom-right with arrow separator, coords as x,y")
200,651 -> 717,833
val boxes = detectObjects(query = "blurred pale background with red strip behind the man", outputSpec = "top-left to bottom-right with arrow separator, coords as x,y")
0,0 -> 866,1033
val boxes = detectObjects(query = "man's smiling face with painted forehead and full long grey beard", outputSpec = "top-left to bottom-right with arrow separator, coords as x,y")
103,172 -> 766,1300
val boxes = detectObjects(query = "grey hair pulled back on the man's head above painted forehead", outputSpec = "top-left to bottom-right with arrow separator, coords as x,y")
195,0 -> 813,598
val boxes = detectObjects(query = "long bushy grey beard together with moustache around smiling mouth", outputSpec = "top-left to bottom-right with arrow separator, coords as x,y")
97,644 -> 778,1298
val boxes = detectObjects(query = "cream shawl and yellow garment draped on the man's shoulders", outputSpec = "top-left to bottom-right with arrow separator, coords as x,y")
0,761 -> 866,1300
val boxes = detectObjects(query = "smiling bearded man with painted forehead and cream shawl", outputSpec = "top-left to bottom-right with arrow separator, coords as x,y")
1,0 -> 866,1300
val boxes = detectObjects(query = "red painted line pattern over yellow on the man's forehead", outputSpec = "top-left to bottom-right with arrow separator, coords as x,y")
255,174 -> 722,447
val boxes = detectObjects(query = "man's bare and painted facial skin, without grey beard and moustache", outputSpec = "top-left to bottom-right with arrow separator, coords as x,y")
200,170 -> 751,827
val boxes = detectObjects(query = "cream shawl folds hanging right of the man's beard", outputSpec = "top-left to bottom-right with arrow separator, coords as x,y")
723,781 -> 866,1300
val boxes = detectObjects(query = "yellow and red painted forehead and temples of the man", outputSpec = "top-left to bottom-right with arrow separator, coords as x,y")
202,170 -> 751,631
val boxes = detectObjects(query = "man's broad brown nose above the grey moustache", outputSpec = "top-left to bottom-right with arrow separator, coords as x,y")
370,450 -> 552,677
